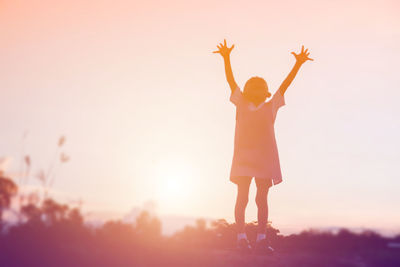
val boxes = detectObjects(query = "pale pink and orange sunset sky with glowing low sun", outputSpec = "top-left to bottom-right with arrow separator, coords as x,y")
0,0 -> 400,232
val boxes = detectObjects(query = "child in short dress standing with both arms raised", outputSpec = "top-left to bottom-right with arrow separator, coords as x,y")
213,40 -> 313,253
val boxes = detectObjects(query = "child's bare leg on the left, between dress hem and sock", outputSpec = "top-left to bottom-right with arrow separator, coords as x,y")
235,176 -> 252,233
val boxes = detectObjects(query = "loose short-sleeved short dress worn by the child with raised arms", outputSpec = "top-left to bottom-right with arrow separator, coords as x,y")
230,87 -> 285,185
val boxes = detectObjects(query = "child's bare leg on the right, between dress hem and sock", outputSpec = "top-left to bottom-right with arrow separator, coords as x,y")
255,178 -> 272,234
